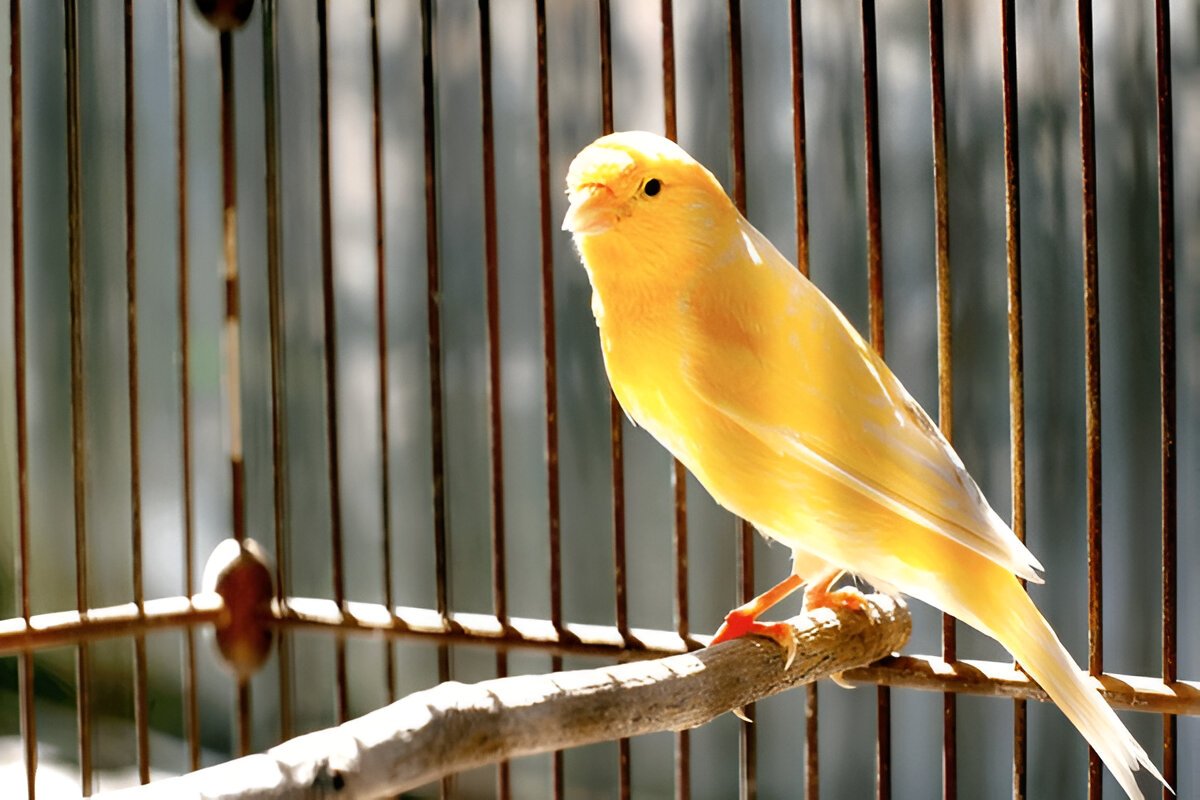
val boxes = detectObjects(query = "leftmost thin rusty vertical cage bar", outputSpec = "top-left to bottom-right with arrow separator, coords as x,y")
8,0 -> 37,800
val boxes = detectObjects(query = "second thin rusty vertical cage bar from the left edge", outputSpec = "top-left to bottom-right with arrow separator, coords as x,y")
64,0 -> 91,796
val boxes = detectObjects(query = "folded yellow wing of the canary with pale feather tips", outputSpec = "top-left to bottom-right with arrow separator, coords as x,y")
680,221 -> 1042,583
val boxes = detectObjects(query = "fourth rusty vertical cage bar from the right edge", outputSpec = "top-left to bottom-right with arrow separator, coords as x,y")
929,0 -> 959,800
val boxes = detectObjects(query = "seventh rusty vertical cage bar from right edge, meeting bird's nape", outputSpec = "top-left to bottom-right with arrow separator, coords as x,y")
728,0 -> 758,800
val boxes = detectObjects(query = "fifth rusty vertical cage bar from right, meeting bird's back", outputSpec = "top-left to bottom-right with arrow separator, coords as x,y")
862,0 -> 892,800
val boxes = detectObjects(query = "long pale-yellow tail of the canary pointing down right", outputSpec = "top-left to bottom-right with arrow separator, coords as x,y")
962,572 -> 1170,800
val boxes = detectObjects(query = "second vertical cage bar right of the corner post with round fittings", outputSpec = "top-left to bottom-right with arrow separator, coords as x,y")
317,0 -> 350,722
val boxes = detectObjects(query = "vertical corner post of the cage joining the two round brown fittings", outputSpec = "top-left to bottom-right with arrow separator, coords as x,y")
220,31 -> 251,756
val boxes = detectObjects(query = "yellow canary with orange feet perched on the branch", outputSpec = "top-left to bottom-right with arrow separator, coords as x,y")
563,132 -> 1163,798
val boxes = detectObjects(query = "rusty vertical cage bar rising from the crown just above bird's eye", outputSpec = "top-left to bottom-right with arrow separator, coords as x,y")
661,6 -> 691,800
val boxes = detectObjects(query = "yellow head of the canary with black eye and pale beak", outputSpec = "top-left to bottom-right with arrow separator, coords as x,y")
563,131 -> 732,242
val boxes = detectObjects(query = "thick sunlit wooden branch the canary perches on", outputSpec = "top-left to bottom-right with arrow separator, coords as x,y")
100,595 -> 912,800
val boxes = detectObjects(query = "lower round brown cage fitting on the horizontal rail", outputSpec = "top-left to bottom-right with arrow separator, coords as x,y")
203,539 -> 275,679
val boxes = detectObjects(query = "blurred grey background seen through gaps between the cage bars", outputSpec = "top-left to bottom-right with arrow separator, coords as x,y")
0,0 -> 1200,799
